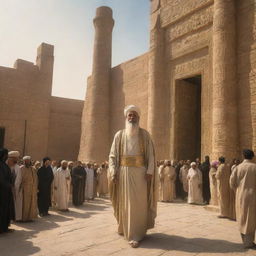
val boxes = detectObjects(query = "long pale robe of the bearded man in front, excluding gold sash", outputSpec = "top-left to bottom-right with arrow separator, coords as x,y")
109,130 -> 157,241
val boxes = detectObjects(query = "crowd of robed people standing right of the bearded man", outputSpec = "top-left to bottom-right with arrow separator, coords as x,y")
157,149 -> 256,249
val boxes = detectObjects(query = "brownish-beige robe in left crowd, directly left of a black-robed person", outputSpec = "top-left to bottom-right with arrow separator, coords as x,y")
20,166 -> 38,221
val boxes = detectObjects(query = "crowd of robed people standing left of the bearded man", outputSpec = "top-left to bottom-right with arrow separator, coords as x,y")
0,148 -> 108,233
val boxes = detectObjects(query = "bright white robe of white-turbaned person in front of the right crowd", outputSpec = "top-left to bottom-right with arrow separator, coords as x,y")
187,168 -> 203,204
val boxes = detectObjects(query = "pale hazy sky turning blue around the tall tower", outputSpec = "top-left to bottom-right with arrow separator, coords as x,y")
0,0 -> 150,99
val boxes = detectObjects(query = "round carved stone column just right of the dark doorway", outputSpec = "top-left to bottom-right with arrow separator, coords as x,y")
212,0 -> 239,159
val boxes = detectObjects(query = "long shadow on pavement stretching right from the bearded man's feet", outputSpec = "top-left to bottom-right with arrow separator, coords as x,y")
140,233 -> 245,253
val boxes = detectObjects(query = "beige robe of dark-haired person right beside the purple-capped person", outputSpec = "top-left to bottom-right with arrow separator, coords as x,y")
216,164 -> 230,217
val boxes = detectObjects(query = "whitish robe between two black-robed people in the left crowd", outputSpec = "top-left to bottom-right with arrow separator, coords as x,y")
54,168 -> 71,210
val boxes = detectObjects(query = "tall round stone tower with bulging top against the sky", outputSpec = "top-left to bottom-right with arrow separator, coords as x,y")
78,6 -> 114,162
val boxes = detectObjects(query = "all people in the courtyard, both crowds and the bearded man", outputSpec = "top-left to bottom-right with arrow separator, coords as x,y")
0,105 -> 256,249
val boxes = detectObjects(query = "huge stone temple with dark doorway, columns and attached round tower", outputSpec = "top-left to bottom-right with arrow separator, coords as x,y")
79,0 -> 256,161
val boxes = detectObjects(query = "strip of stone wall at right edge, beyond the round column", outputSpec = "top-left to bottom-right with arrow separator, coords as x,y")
237,0 -> 256,151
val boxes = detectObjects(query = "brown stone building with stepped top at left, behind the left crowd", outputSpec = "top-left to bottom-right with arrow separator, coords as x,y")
0,43 -> 83,160
